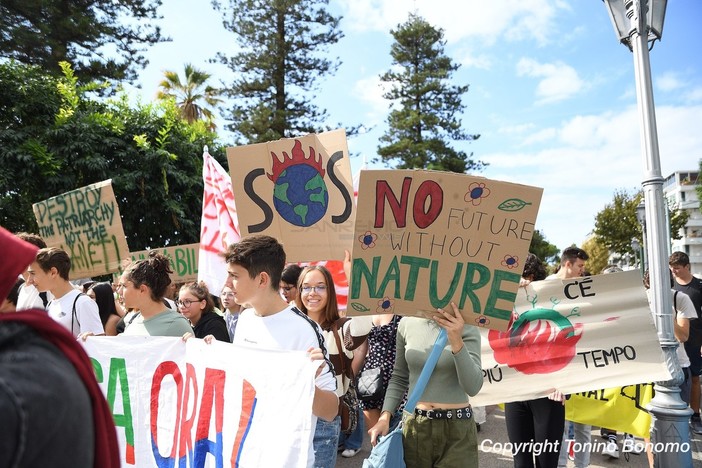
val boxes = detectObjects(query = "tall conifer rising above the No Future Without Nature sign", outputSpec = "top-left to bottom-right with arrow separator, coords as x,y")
378,14 -> 485,173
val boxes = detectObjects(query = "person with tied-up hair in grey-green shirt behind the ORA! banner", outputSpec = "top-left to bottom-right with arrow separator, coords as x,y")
117,251 -> 193,336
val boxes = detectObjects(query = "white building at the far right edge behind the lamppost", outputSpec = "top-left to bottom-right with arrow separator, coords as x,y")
663,171 -> 702,277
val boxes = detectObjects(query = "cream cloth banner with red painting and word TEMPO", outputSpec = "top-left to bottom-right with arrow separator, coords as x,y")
471,271 -> 670,405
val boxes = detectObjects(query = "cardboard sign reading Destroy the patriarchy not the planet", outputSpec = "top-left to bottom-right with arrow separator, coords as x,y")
32,180 -> 129,279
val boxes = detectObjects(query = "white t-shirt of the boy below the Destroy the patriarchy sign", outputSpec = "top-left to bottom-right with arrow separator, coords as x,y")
47,289 -> 105,336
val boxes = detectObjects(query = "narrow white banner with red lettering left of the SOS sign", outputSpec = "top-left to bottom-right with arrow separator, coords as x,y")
197,147 -> 240,296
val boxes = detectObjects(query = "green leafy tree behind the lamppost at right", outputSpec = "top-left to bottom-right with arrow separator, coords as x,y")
593,189 -> 689,257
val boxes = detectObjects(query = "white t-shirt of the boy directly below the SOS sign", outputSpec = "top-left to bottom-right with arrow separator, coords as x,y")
234,307 -> 336,467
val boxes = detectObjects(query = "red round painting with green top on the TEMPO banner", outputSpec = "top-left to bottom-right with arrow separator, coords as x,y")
488,296 -> 583,374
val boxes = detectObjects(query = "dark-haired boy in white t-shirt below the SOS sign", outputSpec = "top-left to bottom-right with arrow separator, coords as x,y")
223,235 -> 339,467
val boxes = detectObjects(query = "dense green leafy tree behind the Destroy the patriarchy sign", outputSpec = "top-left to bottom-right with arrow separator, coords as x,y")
0,62 -> 226,251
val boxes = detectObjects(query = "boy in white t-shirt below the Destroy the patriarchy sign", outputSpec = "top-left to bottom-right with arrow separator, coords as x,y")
27,247 -> 105,337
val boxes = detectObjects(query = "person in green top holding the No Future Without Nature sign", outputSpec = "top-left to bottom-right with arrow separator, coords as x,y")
368,302 -> 483,468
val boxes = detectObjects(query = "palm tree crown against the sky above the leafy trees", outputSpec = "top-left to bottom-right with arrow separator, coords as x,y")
157,63 -> 222,130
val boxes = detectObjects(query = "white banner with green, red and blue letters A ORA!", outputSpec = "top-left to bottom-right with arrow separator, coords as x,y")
85,336 -> 319,468
